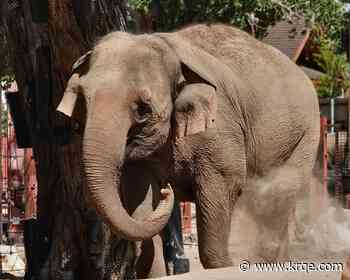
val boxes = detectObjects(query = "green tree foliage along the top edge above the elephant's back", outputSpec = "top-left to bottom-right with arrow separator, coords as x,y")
129,0 -> 345,40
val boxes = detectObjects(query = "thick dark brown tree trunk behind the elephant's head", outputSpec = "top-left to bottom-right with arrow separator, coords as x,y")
0,0 -> 126,280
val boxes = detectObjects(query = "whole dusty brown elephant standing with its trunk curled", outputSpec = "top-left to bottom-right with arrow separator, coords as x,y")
57,24 -> 320,274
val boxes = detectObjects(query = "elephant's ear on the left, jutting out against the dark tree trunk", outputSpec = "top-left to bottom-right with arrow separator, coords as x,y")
56,51 -> 92,117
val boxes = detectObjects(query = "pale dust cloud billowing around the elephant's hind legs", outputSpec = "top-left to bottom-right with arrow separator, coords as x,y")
230,168 -> 350,263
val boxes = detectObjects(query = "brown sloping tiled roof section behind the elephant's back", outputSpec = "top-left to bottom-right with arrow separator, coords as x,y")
263,16 -> 310,61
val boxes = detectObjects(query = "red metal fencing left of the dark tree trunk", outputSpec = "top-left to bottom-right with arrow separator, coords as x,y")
0,94 -> 37,242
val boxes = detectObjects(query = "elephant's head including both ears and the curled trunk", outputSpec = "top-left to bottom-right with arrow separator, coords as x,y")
58,32 -> 218,240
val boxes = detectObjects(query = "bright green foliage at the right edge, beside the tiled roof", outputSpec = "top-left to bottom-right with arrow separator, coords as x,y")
314,38 -> 350,97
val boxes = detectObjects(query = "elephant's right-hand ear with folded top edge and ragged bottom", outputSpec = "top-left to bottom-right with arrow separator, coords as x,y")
158,34 -> 221,137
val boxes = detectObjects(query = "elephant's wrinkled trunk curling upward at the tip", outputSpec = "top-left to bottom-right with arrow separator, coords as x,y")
83,97 -> 174,241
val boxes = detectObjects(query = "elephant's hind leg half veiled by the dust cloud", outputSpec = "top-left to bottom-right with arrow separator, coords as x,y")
249,130 -> 318,261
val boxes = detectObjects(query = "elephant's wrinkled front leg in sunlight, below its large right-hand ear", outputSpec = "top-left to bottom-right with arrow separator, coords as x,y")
174,130 -> 247,268
